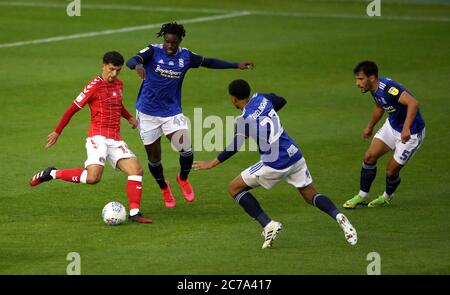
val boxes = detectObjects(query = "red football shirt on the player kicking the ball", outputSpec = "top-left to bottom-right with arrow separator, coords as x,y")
74,76 -> 123,140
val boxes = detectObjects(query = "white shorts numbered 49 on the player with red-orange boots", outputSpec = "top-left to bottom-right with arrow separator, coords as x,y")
136,111 -> 188,145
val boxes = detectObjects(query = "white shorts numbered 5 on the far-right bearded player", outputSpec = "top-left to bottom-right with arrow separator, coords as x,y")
374,119 -> 425,166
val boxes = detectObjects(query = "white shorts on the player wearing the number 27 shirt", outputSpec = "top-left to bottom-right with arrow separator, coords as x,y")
241,158 -> 312,189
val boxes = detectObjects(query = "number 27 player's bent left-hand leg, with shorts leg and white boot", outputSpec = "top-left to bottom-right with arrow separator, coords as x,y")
241,162 -> 283,249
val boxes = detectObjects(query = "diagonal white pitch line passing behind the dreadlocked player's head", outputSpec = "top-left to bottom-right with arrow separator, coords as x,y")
0,12 -> 250,48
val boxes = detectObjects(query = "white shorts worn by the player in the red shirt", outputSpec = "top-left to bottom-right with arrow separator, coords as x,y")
84,135 -> 136,169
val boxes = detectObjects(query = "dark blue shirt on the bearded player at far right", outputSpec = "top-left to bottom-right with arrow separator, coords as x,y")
371,77 -> 425,134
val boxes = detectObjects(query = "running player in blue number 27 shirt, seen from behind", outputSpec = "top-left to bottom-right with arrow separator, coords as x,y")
194,80 -> 357,249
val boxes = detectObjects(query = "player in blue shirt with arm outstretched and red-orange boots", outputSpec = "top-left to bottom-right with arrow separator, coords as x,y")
127,22 -> 253,208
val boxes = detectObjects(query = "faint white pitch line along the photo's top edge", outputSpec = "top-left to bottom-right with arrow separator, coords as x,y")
0,1 -> 450,22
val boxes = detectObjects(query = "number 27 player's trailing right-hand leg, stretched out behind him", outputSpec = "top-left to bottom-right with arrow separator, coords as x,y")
285,158 -> 358,245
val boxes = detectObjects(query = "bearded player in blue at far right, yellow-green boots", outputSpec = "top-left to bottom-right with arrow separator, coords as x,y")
343,61 -> 425,209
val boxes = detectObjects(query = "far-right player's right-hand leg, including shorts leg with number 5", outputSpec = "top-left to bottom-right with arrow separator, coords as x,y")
368,130 -> 425,207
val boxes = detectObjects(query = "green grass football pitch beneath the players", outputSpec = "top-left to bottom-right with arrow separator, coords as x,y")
0,0 -> 450,274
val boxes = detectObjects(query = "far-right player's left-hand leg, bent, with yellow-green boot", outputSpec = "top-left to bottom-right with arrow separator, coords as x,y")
343,122 -> 395,209
